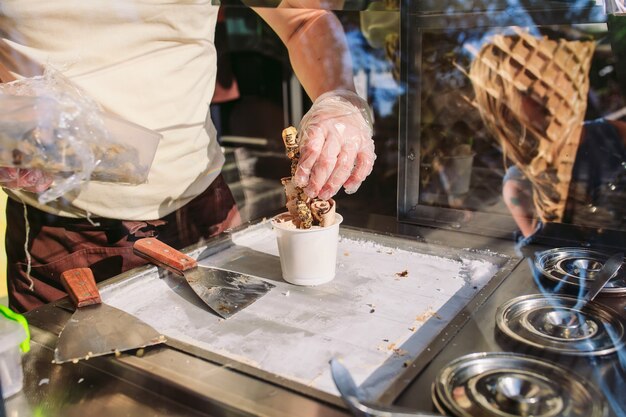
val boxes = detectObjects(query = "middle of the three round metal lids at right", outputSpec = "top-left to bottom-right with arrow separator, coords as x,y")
496,294 -> 626,356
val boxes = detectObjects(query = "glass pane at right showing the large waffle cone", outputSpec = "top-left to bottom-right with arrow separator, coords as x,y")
405,8 -> 626,236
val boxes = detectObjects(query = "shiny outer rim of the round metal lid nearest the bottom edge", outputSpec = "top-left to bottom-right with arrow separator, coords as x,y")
431,352 -> 607,417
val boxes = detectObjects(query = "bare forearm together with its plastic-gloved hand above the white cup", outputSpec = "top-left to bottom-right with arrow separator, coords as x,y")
257,0 -> 376,200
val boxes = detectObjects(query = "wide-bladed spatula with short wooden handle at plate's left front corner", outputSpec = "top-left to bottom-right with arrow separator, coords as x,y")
54,268 -> 166,363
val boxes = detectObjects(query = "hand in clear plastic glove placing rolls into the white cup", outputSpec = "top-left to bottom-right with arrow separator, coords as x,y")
294,90 -> 376,200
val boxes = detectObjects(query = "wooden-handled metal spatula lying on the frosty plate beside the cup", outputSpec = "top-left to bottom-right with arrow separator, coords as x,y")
133,237 -> 274,319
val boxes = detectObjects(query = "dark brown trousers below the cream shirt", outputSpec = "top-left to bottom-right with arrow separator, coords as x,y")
6,175 -> 241,312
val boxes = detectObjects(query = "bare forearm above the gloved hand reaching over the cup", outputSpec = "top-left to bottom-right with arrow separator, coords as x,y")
252,7 -> 354,100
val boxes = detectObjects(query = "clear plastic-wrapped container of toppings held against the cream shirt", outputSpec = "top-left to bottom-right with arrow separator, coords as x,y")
0,69 -> 161,203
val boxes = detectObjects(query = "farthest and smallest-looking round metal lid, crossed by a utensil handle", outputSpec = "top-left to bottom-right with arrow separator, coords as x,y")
535,248 -> 626,296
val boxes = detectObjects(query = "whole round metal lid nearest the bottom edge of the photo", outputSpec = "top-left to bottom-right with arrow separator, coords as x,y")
432,352 -> 605,417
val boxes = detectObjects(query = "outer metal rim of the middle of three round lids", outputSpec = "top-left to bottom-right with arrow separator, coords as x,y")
496,294 -> 626,356
